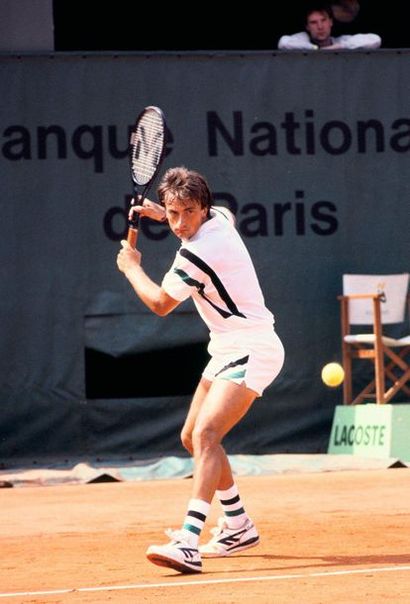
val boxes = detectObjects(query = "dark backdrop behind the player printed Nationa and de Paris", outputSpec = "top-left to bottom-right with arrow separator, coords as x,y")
0,50 -> 410,462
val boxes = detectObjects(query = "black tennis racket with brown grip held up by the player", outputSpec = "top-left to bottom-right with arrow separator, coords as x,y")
127,106 -> 166,247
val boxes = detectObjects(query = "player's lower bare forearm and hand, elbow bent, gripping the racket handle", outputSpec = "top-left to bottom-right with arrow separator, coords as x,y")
117,241 -> 180,317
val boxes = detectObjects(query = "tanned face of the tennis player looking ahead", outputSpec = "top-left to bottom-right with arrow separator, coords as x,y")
165,198 -> 208,241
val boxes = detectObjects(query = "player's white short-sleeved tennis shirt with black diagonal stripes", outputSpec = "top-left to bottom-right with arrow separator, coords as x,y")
162,207 -> 274,334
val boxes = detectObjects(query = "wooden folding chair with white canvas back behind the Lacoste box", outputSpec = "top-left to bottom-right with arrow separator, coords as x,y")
338,273 -> 410,405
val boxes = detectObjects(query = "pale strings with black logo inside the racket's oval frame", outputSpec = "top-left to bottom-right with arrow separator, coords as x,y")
130,110 -> 164,185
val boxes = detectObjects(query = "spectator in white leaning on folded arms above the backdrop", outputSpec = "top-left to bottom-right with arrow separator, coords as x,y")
278,5 -> 381,50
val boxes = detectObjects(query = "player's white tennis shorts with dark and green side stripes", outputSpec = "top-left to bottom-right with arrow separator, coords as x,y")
202,327 -> 285,396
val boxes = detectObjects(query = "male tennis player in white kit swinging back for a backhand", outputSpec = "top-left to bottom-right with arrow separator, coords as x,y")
117,167 -> 284,573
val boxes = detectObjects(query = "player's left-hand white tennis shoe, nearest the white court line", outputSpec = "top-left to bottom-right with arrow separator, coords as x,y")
146,529 -> 202,573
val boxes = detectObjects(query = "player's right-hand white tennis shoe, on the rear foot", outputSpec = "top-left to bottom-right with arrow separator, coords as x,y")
199,518 -> 259,558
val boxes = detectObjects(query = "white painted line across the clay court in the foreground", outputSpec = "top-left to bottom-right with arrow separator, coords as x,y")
0,566 -> 410,598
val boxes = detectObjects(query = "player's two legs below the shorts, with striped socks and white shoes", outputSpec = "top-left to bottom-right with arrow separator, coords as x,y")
147,378 -> 259,573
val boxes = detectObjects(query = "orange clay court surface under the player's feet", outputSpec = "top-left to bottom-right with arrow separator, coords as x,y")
0,468 -> 410,604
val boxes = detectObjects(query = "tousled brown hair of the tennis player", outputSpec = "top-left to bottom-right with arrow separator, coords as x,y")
157,166 -> 212,211
